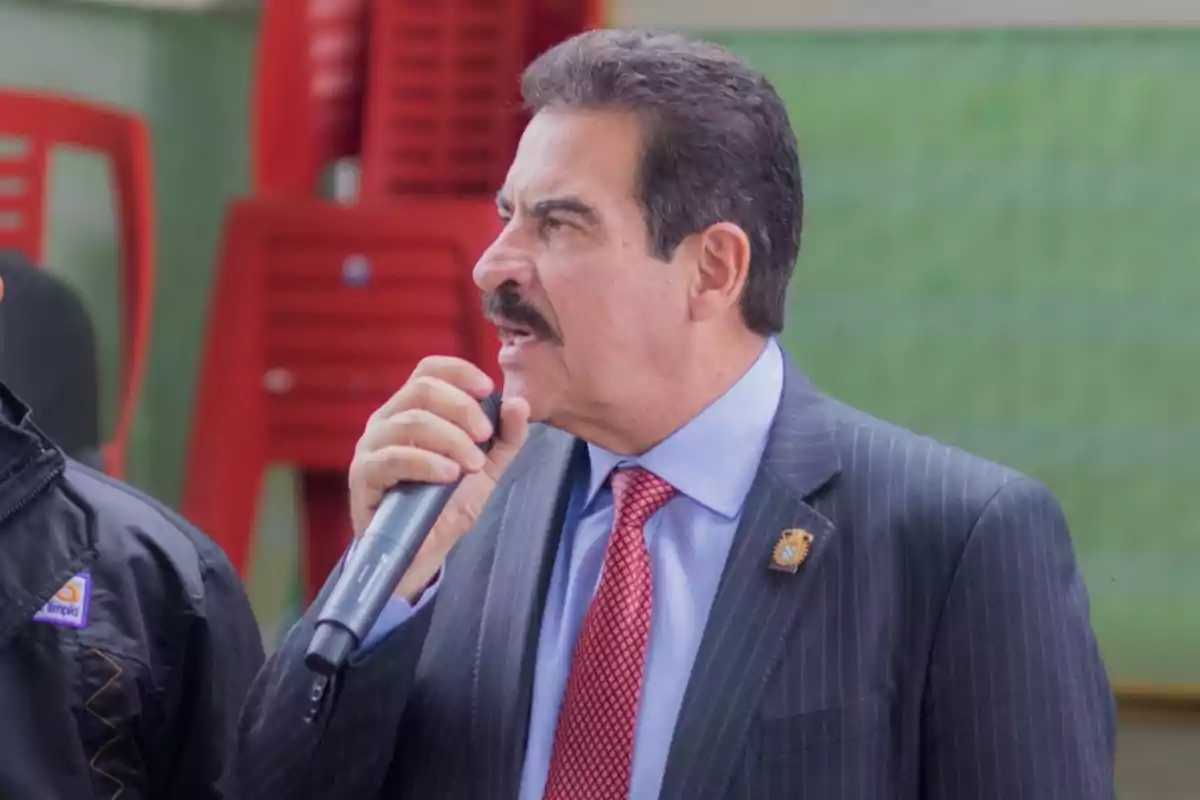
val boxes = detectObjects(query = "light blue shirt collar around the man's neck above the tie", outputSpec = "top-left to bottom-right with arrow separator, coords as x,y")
584,338 -> 784,519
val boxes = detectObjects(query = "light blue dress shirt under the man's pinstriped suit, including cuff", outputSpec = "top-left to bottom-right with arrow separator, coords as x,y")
365,339 -> 784,800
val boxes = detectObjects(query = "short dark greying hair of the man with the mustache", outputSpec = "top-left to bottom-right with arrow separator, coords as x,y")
521,30 -> 804,335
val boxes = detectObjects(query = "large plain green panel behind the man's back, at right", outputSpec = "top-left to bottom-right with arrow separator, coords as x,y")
714,32 -> 1200,684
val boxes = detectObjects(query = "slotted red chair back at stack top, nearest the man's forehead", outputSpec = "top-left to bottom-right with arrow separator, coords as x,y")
361,0 -> 532,199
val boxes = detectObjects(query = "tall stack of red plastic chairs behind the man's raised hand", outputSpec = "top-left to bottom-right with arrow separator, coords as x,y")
184,0 -> 604,596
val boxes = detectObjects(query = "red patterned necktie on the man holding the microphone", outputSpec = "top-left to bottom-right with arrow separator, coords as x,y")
545,469 -> 674,800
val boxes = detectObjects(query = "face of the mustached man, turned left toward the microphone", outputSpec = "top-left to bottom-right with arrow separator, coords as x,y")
475,110 -> 689,432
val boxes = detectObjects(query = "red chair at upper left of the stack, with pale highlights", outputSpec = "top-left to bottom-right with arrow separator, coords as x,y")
252,0 -> 371,197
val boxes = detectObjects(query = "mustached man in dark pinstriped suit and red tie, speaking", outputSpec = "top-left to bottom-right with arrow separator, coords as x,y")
238,31 -> 1115,800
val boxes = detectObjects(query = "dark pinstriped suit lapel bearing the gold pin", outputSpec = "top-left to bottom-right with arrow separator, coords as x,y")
661,363 -> 840,800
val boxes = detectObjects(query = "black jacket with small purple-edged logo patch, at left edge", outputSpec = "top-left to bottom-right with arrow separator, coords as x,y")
0,384 -> 263,800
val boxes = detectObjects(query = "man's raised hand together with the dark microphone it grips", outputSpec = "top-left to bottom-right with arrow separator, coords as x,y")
307,356 -> 529,674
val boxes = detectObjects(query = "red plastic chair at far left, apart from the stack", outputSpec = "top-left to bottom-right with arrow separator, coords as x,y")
0,90 -> 155,477
